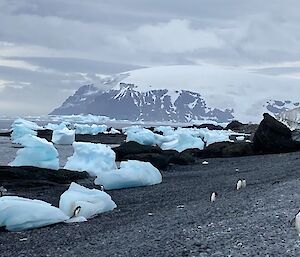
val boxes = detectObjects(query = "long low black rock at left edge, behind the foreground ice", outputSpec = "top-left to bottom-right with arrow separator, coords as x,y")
0,166 -> 89,188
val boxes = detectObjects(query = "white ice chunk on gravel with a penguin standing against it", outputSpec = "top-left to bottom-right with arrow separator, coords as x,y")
59,182 -> 117,219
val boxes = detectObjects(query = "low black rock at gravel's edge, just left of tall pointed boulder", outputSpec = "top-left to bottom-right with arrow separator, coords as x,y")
197,142 -> 254,158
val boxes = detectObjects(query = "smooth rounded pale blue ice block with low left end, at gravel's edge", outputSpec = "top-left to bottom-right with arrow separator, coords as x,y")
95,160 -> 162,190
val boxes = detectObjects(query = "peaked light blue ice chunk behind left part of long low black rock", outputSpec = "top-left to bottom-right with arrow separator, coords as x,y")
9,135 -> 59,170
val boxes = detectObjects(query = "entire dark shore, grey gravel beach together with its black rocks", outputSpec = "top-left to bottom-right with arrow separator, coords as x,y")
0,115 -> 300,257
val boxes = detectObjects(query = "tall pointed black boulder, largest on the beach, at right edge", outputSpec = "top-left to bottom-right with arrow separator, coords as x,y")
253,113 -> 300,153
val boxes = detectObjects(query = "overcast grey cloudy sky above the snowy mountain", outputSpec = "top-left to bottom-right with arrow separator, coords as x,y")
0,0 -> 300,115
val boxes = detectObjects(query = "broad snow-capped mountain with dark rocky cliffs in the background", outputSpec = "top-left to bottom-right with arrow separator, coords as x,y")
51,65 -> 300,122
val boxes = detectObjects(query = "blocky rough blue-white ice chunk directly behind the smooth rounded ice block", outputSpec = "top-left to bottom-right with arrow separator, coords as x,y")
64,142 -> 117,176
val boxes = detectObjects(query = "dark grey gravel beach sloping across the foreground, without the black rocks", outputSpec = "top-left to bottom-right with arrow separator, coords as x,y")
0,152 -> 300,257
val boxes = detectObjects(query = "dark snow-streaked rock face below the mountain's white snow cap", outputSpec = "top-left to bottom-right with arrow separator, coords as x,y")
51,83 -> 233,122
